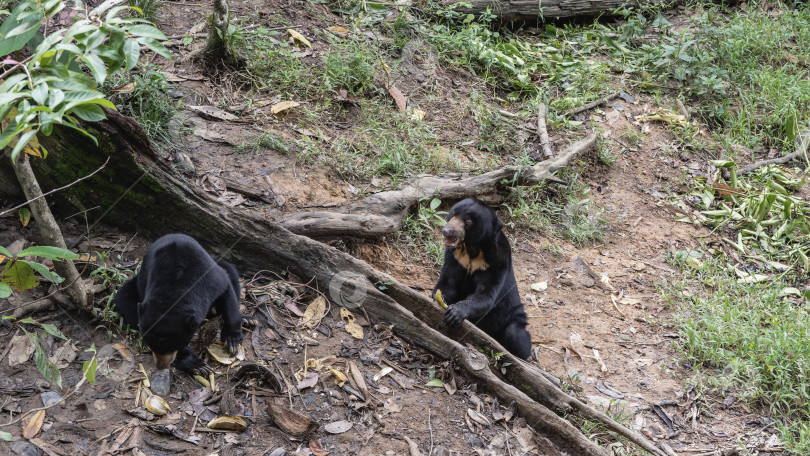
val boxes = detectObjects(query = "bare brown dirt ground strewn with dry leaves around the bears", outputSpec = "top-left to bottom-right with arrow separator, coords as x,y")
0,0 -> 788,456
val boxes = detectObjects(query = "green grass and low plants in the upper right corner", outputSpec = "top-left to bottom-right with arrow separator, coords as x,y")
595,2 -> 810,150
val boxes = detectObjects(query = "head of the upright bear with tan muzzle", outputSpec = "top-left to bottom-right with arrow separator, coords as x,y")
442,198 -> 503,249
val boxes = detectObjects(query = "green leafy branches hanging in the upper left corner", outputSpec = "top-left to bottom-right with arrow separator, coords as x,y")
0,0 -> 171,160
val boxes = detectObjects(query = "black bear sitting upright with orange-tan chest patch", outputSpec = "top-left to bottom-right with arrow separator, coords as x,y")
433,198 -> 532,359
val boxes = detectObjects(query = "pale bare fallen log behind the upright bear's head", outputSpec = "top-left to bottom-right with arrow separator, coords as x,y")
281,133 -> 596,237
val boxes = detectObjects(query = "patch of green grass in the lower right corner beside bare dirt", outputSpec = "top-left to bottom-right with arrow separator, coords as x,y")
665,255 -> 810,454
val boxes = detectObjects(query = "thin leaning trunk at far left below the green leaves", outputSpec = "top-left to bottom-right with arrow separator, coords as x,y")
11,153 -> 93,312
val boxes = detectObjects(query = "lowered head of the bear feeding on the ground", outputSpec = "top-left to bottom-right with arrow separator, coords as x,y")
138,302 -> 202,369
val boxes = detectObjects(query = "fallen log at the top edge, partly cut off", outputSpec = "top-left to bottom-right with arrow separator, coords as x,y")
441,0 -> 662,22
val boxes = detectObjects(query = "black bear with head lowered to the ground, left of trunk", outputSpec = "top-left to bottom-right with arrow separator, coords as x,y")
115,234 -> 249,376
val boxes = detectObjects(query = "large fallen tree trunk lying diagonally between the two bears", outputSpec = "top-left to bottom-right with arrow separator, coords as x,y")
23,113 -> 664,455
